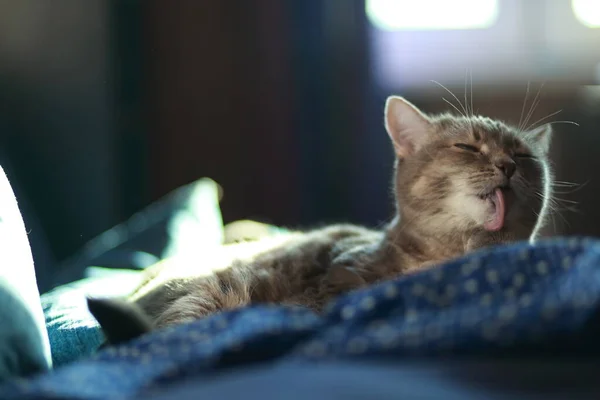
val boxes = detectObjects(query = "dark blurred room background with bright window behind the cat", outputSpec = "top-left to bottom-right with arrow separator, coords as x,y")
0,0 -> 600,291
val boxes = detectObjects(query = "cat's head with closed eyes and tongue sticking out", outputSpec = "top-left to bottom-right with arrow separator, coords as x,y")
385,97 -> 551,245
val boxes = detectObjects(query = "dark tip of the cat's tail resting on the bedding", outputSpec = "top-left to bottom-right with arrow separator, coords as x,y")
87,297 -> 153,345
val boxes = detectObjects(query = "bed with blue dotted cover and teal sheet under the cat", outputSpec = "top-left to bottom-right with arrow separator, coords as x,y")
0,174 -> 600,400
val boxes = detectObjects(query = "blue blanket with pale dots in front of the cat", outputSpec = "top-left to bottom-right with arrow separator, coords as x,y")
0,238 -> 600,399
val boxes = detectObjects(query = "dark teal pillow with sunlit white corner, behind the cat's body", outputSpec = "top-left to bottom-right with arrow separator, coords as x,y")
52,178 -> 223,287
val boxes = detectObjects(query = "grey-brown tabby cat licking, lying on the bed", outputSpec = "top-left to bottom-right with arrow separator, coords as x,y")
88,96 -> 552,343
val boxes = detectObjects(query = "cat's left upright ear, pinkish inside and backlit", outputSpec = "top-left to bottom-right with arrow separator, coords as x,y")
385,96 -> 431,158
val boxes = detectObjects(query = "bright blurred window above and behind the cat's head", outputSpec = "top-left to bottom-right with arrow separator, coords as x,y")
365,0 -> 600,90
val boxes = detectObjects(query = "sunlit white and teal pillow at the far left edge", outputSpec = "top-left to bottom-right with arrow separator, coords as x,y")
0,168 -> 51,380
